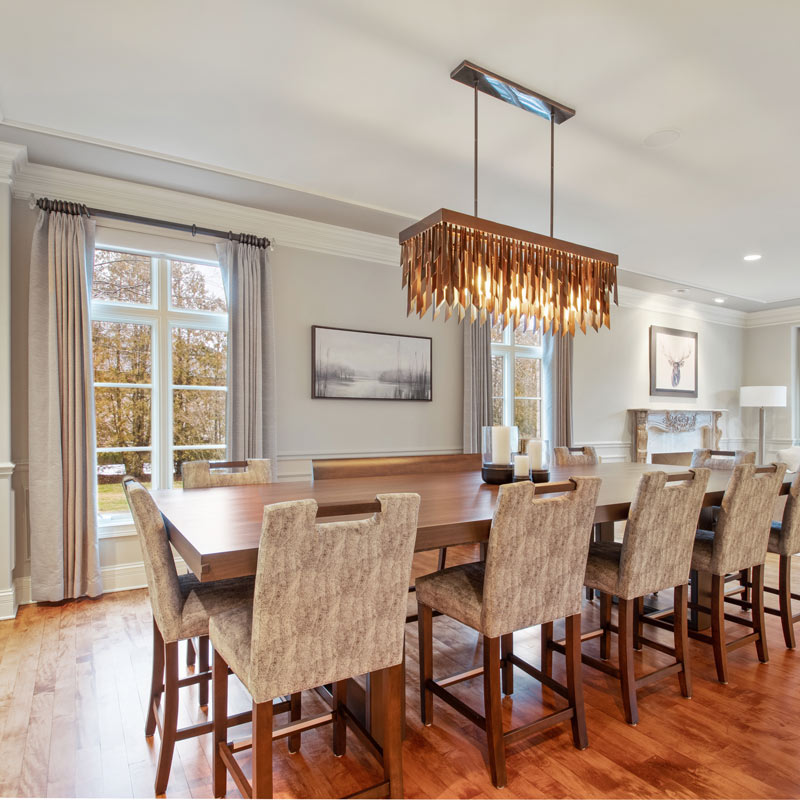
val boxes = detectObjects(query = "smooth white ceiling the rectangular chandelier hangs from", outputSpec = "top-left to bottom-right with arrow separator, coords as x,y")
0,0 -> 800,308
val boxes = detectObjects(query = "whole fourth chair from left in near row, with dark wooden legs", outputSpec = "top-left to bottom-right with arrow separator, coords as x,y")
689,464 -> 786,683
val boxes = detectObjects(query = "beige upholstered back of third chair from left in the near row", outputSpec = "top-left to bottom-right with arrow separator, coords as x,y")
619,468 -> 711,599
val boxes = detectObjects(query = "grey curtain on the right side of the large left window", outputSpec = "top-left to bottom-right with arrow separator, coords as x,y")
217,242 -> 278,475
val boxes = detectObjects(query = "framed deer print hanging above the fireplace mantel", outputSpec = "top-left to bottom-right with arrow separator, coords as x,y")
650,325 -> 697,397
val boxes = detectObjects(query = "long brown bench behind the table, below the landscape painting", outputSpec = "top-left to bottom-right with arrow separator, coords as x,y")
311,453 -> 481,622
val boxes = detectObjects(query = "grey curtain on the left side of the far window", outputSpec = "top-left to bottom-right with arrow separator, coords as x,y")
461,320 -> 492,453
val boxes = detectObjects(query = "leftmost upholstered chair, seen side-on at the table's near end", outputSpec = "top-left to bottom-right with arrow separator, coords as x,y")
122,476 -> 274,794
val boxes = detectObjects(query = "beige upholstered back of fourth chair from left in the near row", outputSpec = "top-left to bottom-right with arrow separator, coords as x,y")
711,464 -> 786,575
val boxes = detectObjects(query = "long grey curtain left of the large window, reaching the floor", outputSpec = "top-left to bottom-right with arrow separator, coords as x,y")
28,206 -> 103,601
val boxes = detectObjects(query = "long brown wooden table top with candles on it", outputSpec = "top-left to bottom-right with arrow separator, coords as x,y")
152,463 -> 790,581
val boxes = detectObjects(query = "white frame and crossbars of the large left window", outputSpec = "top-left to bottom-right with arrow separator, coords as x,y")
91,241 -> 228,538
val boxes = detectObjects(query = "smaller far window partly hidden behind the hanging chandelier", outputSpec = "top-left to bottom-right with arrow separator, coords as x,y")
492,326 -> 542,439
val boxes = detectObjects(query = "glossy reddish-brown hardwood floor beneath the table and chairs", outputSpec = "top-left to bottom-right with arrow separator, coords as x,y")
0,548 -> 800,798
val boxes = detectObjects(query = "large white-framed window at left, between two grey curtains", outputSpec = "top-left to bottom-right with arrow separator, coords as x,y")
92,248 -> 228,524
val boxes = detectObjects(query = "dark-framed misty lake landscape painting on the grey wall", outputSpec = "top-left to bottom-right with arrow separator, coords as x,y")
311,325 -> 433,400
